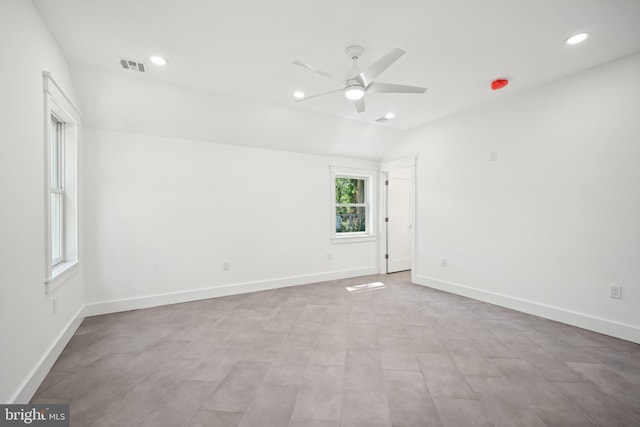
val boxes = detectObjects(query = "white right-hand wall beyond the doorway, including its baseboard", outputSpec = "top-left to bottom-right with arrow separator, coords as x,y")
387,54 -> 640,342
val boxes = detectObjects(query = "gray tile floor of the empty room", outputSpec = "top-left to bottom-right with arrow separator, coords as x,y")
32,273 -> 640,427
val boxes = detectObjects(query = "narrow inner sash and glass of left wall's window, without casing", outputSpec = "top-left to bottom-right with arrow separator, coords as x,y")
49,114 -> 64,267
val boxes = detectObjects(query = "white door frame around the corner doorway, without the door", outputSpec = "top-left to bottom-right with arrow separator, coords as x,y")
378,157 -> 417,282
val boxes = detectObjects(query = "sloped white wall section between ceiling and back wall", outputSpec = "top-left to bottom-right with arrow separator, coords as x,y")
71,61 -> 401,159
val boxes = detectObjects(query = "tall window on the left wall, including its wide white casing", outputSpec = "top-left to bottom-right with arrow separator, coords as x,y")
44,72 -> 79,292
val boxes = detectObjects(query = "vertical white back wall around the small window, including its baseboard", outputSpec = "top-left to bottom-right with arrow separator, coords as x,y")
84,129 -> 377,313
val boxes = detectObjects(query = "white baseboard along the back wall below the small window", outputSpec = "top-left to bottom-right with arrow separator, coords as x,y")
85,267 -> 378,316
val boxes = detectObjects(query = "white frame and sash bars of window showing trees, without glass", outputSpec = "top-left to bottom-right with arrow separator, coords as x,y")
330,166 -> 377,243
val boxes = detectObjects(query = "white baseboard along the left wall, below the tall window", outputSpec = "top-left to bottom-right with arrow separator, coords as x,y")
10,306 -> 84,404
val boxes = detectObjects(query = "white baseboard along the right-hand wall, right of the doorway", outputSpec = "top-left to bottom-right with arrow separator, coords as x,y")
413,275 -> 640,344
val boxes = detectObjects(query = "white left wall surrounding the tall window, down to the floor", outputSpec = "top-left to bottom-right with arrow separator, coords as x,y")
0,0 -> 84,403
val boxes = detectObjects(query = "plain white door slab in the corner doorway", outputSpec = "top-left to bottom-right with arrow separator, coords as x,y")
387,168 -> 411,273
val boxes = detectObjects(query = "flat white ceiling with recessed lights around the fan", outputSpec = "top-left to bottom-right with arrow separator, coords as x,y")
35,0 -> 640,129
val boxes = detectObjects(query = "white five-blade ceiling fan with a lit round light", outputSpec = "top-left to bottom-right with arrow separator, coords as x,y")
293,45 -> 427,113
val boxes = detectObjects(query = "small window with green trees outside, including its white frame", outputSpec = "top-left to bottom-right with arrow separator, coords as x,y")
331,167 -> 376,243
